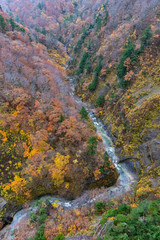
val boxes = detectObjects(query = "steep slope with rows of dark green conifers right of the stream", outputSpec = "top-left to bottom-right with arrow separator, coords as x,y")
65,0 -> 160,203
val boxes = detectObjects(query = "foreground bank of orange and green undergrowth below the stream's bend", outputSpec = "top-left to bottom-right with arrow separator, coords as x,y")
9,194 -> 160,240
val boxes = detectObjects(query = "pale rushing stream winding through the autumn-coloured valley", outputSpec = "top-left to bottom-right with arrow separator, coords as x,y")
0,78 -> 137,240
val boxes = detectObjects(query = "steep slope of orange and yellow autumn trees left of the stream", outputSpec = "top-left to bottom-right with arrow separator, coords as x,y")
0,7 -> 117,204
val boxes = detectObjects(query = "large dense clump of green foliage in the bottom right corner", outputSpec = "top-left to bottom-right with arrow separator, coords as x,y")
101,200 -> 160,240
